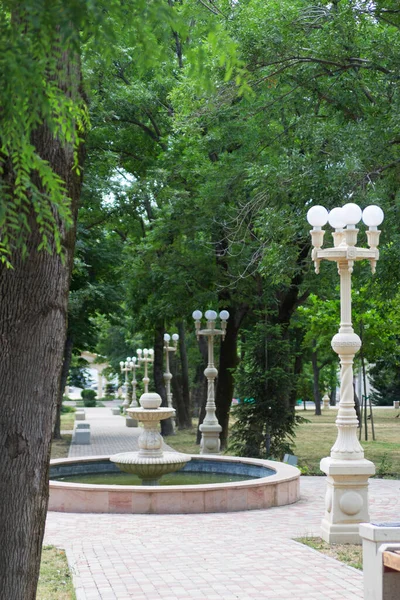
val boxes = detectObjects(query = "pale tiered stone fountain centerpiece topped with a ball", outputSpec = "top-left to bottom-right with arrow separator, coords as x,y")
110,392 -> 191,485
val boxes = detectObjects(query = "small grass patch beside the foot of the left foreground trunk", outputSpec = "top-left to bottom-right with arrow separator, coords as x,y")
36,546 -> 75,600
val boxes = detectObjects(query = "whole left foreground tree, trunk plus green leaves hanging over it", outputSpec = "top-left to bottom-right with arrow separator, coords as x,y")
0,2 -> 83,600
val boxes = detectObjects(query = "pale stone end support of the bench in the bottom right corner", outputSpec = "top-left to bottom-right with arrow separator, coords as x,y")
360,523 -> 400,600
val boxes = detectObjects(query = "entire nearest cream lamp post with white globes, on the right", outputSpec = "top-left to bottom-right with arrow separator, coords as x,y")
307,203 -> 383,543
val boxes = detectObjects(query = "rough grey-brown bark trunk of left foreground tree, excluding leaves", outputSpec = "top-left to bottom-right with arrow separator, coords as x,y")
0,39 -> 82,600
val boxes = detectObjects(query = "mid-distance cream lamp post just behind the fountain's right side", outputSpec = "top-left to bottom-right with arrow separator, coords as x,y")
192,310 -> 229,454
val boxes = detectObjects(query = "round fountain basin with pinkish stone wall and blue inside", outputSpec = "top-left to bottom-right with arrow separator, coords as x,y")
49,455 -> 300,514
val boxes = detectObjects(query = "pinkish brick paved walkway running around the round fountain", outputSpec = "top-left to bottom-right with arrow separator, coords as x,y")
45,409 -> 400,600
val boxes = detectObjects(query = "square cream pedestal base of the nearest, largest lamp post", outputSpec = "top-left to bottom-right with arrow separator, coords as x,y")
320,457 -> 375,544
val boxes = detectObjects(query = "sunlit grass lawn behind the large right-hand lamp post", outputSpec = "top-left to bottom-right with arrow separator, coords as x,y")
294,408 -> 400,477
